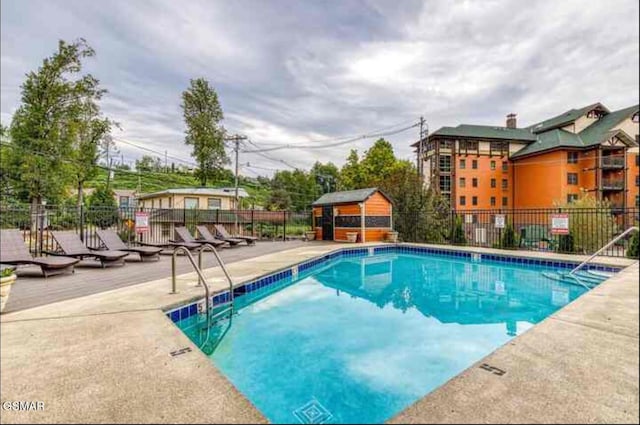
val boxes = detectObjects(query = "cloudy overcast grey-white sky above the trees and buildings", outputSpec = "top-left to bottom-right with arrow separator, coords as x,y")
1,0 -> 640,176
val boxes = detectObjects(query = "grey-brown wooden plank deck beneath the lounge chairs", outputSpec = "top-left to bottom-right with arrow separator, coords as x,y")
3,240 -> 314,313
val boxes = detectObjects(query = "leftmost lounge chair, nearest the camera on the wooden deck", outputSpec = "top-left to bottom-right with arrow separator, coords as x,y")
0,229 -> 80,277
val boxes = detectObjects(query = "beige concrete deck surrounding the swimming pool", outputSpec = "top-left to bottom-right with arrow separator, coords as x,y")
0,243 -> 638,423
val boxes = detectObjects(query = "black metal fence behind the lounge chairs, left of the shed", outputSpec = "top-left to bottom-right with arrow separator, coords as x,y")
0,205 -> 311,254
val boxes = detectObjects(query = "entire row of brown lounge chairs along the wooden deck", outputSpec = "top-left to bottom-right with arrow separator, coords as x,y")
0,225 -> 257,277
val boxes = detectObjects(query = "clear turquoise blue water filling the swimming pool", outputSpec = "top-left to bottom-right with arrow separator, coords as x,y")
177,253 -> 585,423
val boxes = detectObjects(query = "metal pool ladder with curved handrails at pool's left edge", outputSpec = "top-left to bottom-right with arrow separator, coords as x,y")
171,244 -> 233,333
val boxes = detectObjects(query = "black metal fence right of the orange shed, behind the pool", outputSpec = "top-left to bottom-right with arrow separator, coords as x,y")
394,208 -> 640,257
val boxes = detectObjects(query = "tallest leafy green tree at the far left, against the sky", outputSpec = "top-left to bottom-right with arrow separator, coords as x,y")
7,39 -> 96,204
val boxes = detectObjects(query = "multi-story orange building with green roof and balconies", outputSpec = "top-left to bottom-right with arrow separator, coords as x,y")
412,103 -> 640,210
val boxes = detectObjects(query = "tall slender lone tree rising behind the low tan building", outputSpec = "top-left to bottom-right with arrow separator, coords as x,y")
181,78 -> 229,186
